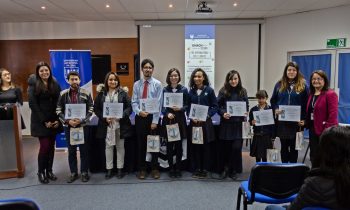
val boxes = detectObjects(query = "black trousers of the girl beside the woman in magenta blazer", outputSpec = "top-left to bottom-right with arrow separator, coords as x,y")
280,137 -> 298,163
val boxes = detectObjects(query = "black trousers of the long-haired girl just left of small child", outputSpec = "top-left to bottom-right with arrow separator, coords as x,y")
217,139 -> 243,173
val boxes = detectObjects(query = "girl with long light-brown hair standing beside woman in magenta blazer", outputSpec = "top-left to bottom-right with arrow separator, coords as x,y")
271,62 -> 308,163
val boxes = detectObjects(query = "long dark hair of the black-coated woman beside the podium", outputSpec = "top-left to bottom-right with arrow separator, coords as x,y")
35,61 -> 57,95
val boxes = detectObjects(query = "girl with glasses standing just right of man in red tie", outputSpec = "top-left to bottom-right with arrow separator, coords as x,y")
162,68 -> 188,178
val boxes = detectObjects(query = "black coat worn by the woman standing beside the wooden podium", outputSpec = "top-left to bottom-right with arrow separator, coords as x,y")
28,75 -> 62,137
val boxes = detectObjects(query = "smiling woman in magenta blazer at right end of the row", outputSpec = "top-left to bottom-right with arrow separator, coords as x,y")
306,70 -> 338,165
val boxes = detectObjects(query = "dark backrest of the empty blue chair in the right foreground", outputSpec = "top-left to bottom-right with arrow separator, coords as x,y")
248,163 -> 310,199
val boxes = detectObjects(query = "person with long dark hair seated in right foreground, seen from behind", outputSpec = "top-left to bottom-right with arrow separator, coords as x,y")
266,126 -> 350,210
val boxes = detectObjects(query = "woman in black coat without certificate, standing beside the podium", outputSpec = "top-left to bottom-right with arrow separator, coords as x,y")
28,62 -> 62,184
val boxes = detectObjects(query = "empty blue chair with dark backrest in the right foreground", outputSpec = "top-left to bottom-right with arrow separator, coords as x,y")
237,163 -> 310,210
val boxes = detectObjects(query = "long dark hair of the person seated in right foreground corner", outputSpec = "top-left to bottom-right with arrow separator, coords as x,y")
314,126 -> 350,209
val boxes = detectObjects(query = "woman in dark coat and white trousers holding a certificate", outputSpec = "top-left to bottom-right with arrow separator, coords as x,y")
94,72 -> 131,179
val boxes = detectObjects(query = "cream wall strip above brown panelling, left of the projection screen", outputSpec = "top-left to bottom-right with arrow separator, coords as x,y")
0,21 -> 137,40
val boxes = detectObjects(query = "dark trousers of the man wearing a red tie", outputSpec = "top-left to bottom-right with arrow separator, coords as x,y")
135,114 -> 159,171
